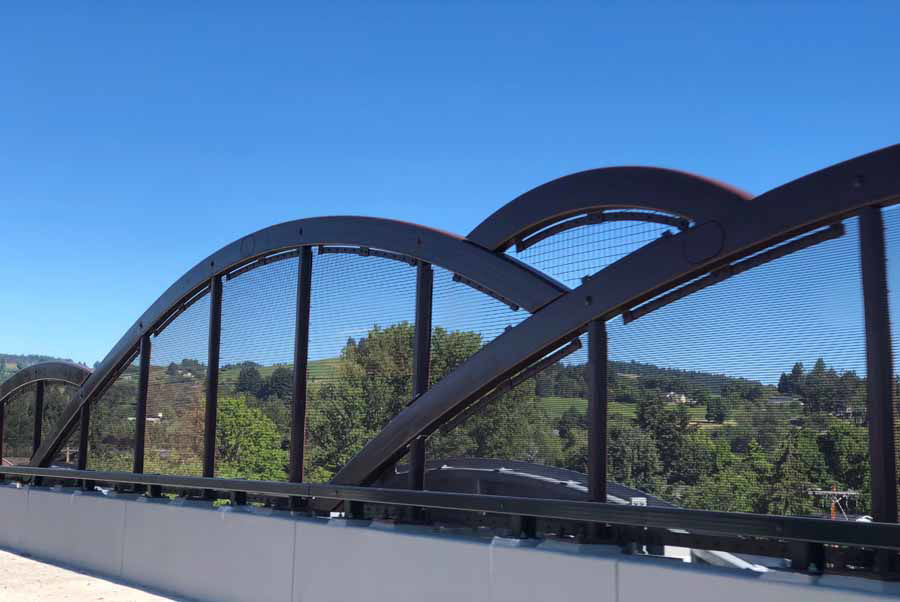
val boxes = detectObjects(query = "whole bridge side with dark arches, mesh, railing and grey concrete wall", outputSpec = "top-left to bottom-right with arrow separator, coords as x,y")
0,146 -> 900,601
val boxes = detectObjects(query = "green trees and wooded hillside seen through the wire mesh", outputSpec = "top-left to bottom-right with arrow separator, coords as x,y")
7,322 -> 870,514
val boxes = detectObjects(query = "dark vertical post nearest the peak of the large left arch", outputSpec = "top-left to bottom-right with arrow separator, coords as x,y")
288,247 -> 312,483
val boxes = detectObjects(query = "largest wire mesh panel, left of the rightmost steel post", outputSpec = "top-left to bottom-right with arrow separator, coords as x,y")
588,219 -> 870,516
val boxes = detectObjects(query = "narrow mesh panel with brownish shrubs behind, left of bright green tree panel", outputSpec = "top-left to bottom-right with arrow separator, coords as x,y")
147,294 -> 209,476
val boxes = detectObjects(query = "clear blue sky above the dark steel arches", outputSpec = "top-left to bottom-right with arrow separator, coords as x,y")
0,2 -> 900,370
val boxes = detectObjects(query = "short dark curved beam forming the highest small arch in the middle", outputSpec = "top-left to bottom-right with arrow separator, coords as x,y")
466,167 -> 750,251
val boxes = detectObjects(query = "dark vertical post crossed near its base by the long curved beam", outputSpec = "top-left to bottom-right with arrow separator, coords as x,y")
409,261 -> 434,490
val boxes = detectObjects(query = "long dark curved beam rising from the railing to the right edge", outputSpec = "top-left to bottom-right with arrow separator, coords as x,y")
332,145 -> 900,484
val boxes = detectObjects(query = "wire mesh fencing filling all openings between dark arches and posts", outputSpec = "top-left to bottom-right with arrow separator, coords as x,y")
35,205 -> 900,518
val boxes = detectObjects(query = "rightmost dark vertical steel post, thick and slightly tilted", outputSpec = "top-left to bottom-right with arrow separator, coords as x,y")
859,207 -> 897,523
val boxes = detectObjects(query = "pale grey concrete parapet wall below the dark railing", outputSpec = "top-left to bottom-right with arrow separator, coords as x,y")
0,485 -> 900,602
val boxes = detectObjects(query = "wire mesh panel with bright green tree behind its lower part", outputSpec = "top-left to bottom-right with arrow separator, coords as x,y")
216,258 -> 298,481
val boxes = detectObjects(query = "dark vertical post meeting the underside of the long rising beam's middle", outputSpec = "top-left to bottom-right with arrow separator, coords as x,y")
588,320 -> 609,502
